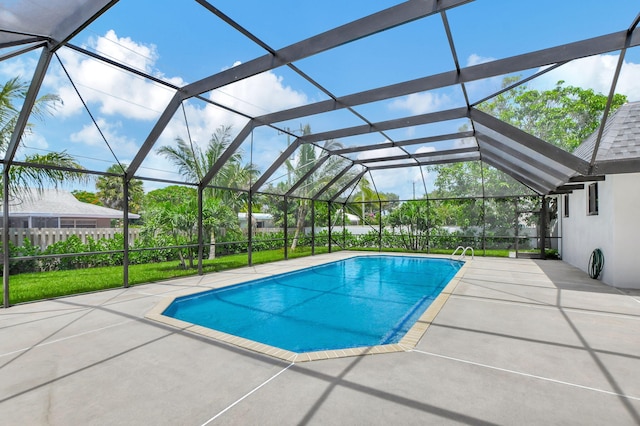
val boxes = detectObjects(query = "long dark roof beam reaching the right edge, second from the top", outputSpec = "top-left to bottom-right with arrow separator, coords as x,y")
256,29 -> 640,125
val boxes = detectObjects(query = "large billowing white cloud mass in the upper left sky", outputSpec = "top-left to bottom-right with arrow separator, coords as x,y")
31,30 -> 308,183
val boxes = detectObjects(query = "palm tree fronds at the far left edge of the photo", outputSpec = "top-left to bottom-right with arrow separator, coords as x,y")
0,77 -> 86,195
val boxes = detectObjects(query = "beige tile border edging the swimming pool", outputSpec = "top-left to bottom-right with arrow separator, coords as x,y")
145,251 -> 472,362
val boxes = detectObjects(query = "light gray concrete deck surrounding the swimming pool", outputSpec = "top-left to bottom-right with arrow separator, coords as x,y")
0,252 -> 640,425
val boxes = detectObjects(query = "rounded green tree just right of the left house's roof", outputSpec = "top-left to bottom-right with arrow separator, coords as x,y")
96,164 -> 144,213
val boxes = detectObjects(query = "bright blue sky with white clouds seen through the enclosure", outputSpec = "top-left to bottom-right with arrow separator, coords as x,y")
0,0 -> 640,198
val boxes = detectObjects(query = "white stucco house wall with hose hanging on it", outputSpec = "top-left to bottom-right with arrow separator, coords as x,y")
561,173 -> 640,288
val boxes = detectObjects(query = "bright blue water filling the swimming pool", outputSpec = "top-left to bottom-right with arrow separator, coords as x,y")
163,256 -> 462,353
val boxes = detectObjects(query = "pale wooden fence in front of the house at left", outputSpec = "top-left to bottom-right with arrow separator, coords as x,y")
0,228 -> 140,250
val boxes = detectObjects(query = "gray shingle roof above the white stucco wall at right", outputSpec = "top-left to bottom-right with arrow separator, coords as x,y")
573,102 -> 640,161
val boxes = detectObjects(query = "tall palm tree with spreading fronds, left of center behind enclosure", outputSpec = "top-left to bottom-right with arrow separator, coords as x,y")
158,126 -> 260,259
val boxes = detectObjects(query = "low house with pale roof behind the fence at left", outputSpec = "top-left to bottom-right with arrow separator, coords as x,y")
0,189 -> 140,228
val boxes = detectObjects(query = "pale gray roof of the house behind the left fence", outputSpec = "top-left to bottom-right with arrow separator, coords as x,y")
0,189 -> 140,219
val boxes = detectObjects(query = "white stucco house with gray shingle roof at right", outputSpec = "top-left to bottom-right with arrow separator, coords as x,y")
559,102 -> 640,288
